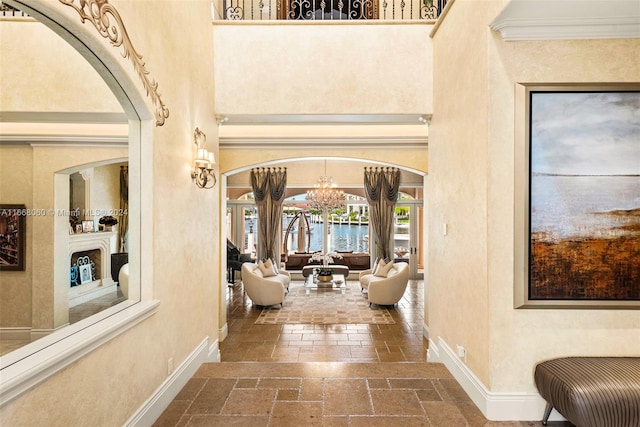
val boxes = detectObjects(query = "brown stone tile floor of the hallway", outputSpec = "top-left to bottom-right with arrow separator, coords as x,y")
154,281 -> 571,427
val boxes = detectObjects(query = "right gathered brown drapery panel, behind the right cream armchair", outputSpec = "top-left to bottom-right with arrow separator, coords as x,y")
364,167 -> 400,259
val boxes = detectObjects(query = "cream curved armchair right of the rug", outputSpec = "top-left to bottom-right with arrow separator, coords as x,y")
359,262 -> 409,305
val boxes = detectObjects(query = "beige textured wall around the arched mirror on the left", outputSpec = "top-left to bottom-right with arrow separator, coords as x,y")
0,1 -> 220,425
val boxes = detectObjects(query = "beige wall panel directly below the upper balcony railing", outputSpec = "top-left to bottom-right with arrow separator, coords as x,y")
214,21 -> 432,114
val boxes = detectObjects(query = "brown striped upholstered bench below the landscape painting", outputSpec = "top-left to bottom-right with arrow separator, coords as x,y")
534,357 -> 640,427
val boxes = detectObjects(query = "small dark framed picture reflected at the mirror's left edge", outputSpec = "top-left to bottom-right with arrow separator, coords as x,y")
0,205 -> 27,271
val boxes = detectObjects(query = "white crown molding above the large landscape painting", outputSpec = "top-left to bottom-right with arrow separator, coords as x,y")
490,0 -> 640,41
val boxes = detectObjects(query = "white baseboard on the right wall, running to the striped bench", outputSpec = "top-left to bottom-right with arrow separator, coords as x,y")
427,337 -> 565,421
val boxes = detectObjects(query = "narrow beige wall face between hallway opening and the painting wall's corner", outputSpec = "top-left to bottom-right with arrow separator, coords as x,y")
426,1 -> 499,384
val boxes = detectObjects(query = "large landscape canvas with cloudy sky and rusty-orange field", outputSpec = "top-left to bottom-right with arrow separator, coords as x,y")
528,90 -> 640,308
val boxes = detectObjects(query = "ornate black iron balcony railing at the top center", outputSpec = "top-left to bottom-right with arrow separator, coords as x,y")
223,0 -> 447,21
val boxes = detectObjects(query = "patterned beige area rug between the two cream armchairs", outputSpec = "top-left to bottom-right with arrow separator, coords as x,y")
255,282 -> 396,325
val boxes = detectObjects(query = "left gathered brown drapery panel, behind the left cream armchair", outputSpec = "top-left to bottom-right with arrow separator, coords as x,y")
251,168 -> 287,263
